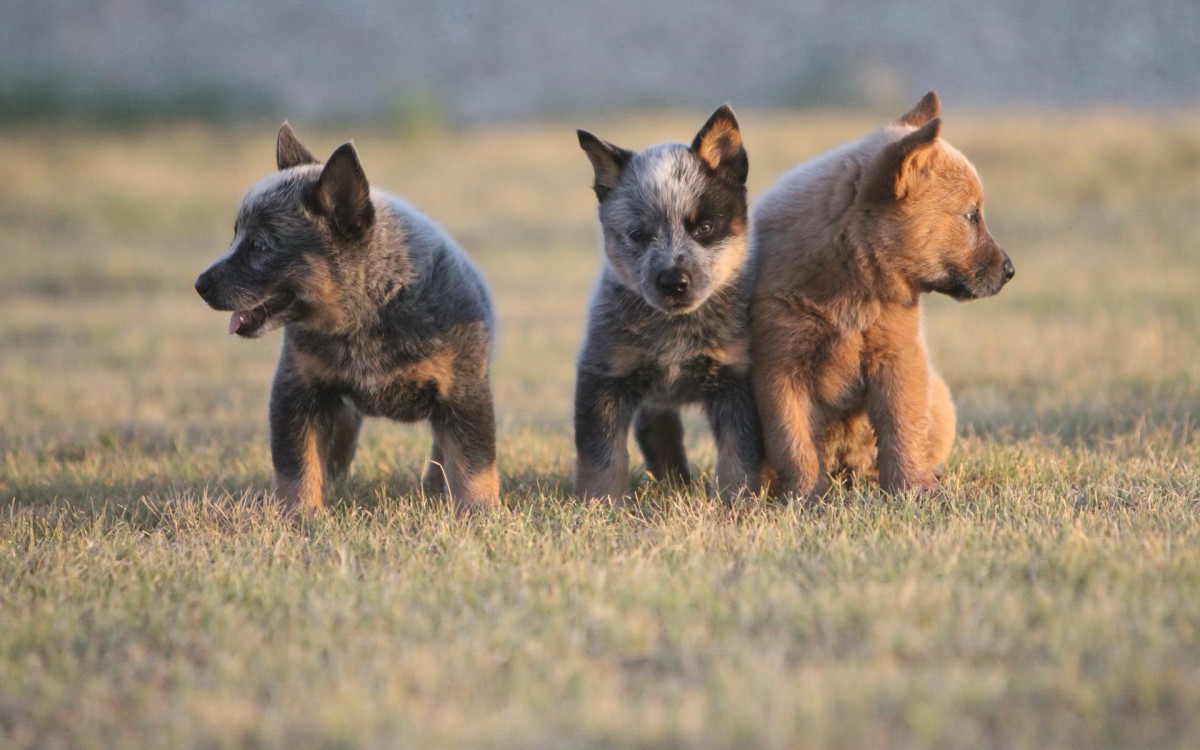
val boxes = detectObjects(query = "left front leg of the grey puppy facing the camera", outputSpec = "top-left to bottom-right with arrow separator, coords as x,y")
575,368 -> 638,503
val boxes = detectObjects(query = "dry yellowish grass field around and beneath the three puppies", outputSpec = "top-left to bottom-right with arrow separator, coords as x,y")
0,112 -> 1200,749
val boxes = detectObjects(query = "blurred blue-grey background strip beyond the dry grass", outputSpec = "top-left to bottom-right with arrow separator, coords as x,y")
0,0 -> 1200,122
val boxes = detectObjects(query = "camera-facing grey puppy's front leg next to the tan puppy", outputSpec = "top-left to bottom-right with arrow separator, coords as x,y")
704,372 -> 763,504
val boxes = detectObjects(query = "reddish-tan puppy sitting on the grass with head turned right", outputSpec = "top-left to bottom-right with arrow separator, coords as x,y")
751,91 -> 1014,499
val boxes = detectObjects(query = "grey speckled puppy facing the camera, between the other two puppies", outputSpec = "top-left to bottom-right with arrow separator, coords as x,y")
575,106 -> 763,503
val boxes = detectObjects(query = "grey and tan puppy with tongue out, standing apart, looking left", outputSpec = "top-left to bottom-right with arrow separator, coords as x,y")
196,122 -> 499,510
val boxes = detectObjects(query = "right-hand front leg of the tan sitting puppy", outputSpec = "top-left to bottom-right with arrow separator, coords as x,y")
865,307 -> 937,492
